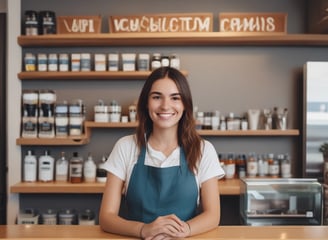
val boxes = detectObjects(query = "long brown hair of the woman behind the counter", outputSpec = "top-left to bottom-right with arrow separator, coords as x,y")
136,67 -> 202,171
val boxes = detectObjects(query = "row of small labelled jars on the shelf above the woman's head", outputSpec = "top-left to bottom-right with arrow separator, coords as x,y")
24,52 -> 180,72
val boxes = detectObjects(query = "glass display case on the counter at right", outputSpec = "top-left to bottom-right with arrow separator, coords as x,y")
240,178 -> 323,225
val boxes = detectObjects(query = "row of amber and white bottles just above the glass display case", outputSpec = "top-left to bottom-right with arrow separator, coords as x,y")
219,153 -> 292,179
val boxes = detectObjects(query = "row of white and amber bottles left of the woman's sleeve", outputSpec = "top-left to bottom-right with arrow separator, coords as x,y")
23,150 -> 107,183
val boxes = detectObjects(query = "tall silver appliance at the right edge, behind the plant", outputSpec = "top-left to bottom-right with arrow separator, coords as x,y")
302,62 -> 328,182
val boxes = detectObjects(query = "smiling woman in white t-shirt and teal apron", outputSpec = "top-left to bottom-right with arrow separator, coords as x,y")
99,67 -> 224,239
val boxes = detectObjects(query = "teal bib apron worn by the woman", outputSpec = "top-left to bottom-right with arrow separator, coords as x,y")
126,147 -> 198,223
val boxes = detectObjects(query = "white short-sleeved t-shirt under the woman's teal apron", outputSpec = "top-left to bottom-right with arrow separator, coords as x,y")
103,135 -> 225,193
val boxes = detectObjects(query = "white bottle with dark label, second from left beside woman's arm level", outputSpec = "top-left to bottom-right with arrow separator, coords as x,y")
39,150 -> 55,182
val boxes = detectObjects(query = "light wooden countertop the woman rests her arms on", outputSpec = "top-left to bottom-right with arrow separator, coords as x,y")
0,225 -> 328,240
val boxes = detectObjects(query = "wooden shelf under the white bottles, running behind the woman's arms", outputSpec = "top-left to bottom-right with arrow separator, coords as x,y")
10,179 -> 240,195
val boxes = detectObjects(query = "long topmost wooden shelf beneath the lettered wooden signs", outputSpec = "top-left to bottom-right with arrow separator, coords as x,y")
18,32 -> 328,47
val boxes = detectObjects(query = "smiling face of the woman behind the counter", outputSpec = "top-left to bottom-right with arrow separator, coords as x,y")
148,77 -> 184,128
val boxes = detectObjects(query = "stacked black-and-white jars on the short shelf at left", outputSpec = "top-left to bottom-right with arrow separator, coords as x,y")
22,90 -> 86,138
